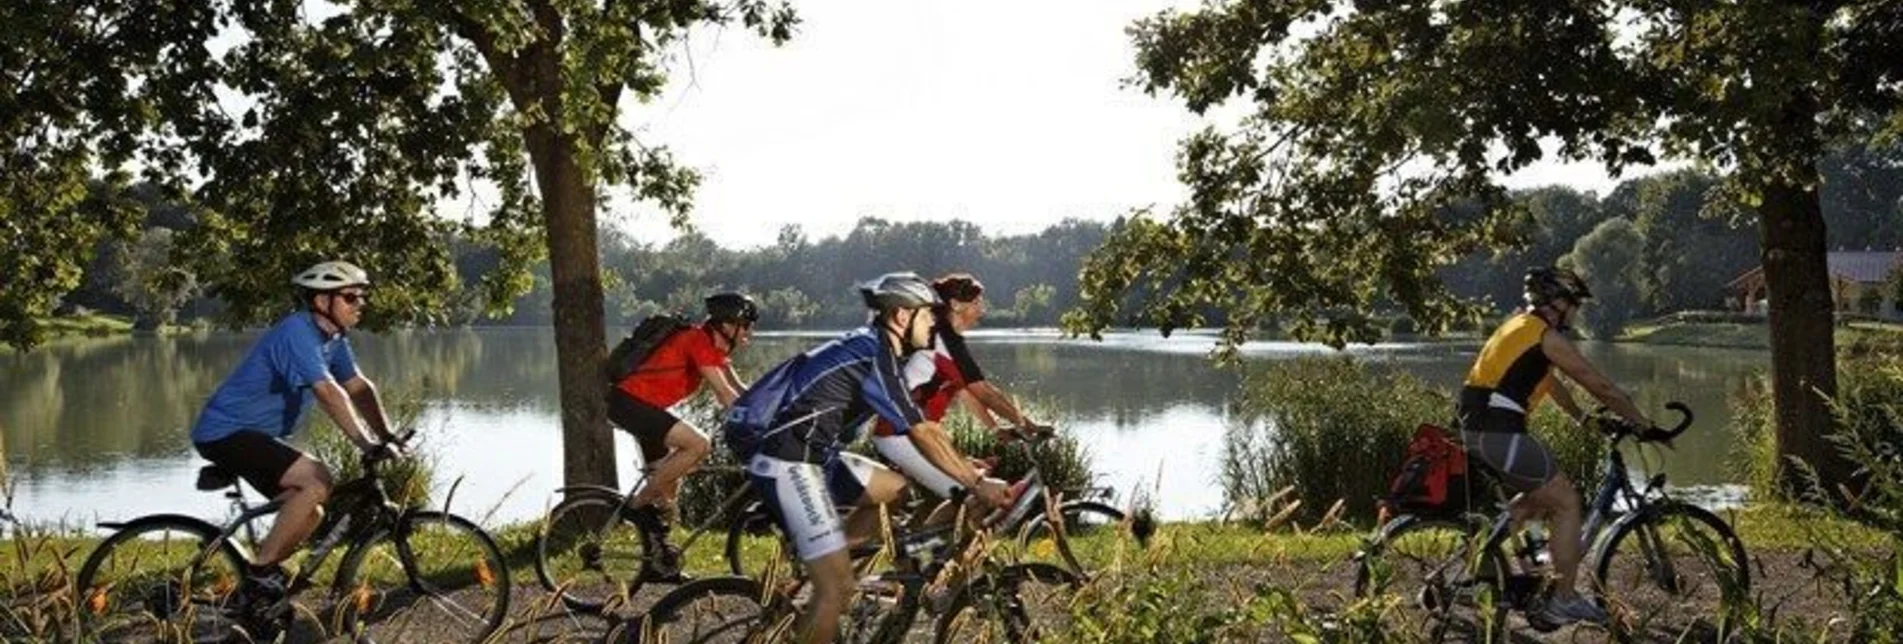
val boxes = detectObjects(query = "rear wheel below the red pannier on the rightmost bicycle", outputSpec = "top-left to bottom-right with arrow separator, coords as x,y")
1355,514 -> 1507,642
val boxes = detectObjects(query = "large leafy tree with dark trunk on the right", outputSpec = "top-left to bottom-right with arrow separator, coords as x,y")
1069,0 -> 1903,490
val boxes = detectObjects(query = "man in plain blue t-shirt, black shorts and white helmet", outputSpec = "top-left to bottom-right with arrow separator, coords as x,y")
192,261 -> 396,600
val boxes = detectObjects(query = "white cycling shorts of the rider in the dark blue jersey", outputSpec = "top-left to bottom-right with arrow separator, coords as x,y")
746,452 -> 885,562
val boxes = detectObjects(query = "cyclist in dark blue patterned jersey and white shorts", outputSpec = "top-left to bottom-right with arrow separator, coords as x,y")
723,272 -> 1009,642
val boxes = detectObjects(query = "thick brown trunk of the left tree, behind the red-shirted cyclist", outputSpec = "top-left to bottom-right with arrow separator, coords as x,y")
527,124 -> 617,488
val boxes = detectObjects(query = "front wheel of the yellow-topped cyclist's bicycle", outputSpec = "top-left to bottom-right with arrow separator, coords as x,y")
1593,503 -> 1751,640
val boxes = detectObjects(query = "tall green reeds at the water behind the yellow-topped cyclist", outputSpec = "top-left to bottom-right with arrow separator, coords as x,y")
1222,356 -> 1606,520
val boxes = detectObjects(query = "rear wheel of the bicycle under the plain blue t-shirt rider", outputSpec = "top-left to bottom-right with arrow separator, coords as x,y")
74,514 -> 255,642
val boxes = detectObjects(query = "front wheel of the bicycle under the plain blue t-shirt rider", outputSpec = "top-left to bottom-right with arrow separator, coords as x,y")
333,511 -> 508,642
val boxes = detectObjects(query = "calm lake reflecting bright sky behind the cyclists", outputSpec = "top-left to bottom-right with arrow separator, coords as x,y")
0,328 -> 1770,524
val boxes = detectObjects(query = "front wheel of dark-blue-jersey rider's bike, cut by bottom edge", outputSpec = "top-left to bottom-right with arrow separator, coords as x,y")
932,562 -> 1081,644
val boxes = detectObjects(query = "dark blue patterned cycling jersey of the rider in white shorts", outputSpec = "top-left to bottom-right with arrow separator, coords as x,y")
725,328 -> 925,463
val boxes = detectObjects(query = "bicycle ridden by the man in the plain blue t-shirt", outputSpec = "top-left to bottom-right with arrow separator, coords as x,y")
76,436 -> 508,642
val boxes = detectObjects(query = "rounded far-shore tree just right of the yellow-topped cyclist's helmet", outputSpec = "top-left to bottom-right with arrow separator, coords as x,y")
1559,219 -> 1646,339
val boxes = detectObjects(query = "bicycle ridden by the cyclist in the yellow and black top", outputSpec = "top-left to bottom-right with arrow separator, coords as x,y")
1355,402 -> 1751,642
